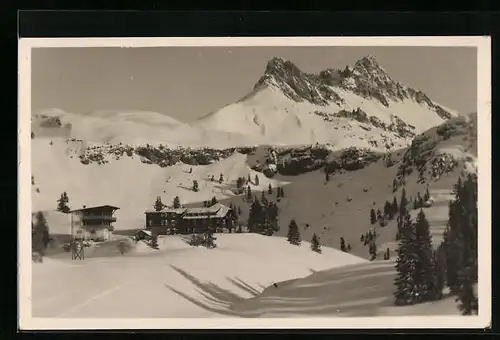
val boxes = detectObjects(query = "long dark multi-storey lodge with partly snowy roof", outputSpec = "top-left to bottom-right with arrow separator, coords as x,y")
145,203 -> 234,235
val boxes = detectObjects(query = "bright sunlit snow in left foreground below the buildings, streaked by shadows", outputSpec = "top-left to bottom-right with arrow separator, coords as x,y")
32,234 -> 366,318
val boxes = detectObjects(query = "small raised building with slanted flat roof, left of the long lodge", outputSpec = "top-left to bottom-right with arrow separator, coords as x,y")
70,205 -> 120,241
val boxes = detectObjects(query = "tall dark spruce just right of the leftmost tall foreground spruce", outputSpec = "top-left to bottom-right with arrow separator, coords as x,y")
413,209 -> 436,302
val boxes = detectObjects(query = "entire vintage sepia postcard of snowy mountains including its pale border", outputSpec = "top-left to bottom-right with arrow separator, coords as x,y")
18,37 -> 491,330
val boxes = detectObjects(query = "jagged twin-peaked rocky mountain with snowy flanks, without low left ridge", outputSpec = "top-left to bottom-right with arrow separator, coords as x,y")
194,56 -> 457,150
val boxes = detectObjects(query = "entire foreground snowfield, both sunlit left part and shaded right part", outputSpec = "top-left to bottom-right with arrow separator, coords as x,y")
32,234 -> 458,318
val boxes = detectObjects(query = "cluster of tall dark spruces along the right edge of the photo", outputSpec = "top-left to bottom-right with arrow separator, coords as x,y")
394,175 -> 478,315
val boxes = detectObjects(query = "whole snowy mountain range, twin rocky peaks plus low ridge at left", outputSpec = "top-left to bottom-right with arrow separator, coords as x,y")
32,56 -> 456,151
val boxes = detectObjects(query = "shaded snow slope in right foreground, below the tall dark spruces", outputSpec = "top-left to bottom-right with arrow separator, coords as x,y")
231,261 -> 466,318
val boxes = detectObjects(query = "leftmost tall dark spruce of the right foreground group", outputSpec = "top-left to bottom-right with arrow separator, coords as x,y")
394,213 -> 416,305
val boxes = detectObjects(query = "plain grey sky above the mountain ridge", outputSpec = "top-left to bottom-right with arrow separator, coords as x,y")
32,47 -> 477,121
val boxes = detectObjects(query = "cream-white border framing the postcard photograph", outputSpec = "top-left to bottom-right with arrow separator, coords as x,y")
18,36 -> 492,330
